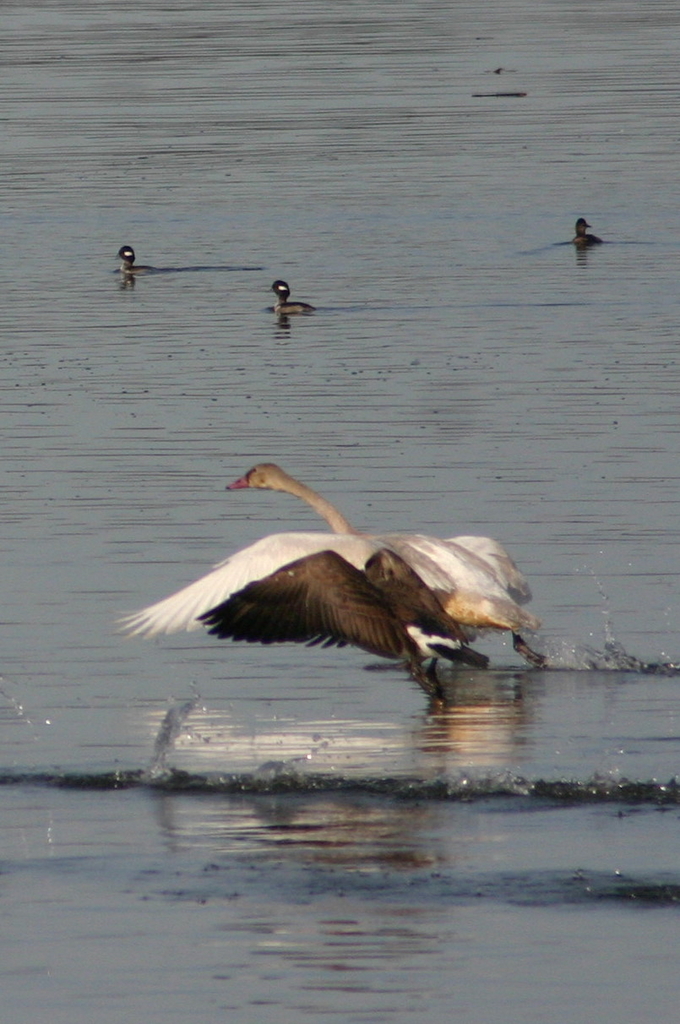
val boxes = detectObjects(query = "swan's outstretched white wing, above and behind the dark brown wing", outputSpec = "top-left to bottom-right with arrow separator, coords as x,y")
119,534 -> 379,637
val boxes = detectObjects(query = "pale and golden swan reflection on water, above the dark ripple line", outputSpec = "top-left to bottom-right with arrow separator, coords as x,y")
143,663 -> 541,782
